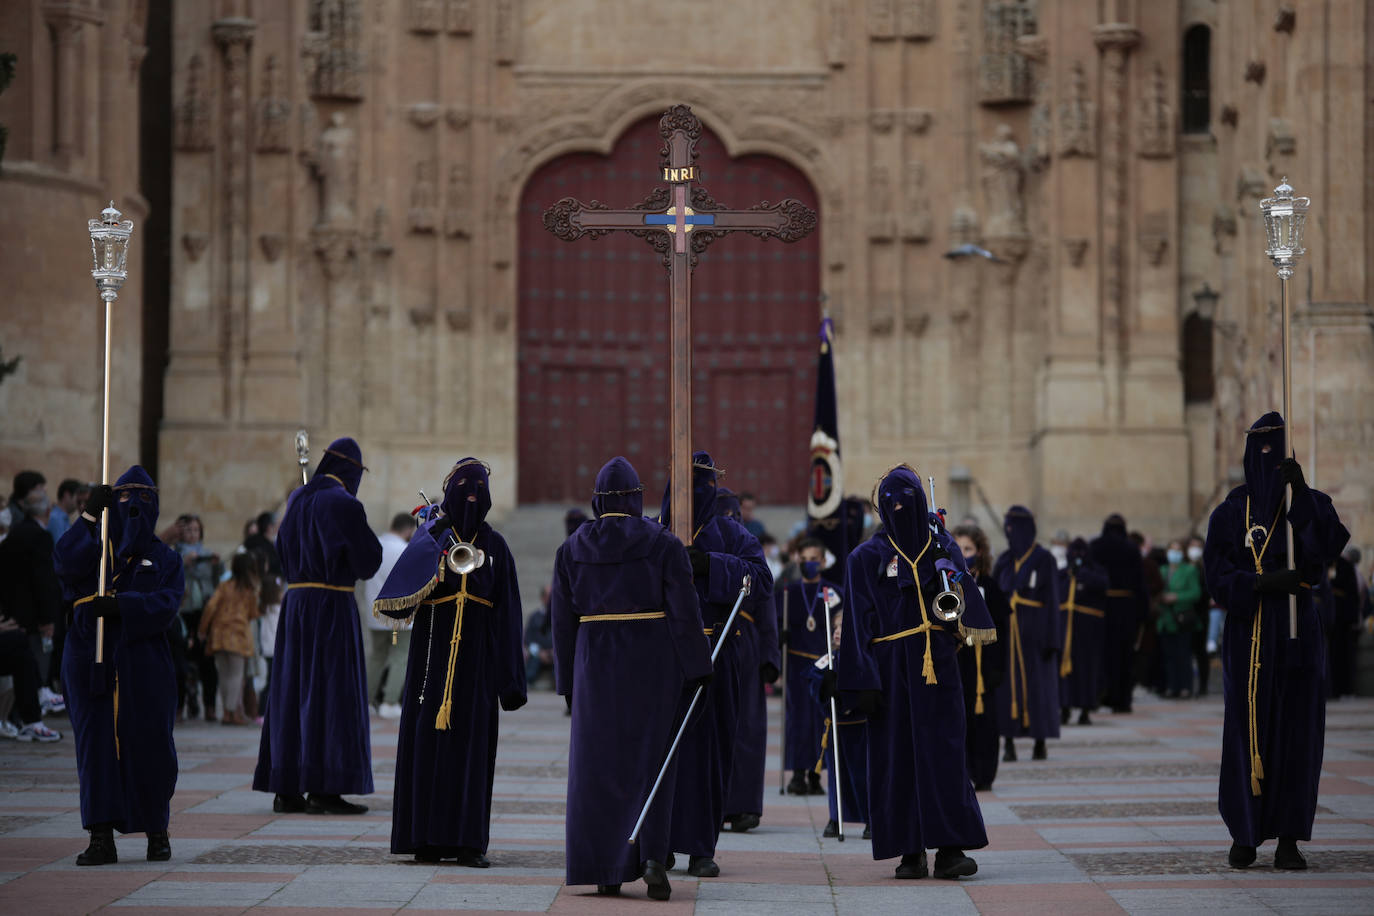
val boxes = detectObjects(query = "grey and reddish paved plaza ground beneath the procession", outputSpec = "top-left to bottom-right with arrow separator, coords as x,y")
0,692 -> 1374,916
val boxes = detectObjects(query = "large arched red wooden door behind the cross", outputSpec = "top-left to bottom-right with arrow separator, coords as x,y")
517,117 -> 820,512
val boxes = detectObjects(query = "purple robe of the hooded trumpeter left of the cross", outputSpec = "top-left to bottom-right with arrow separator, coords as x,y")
378,520 -> 526,856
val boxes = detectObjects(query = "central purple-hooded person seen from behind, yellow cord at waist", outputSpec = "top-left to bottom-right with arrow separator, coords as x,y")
550,457 -> 710,884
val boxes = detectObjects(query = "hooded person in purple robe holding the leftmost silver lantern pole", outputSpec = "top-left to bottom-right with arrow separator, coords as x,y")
54,464 -> 185,834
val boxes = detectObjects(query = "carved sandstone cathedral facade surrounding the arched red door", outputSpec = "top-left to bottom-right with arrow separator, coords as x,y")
0,0 -> 1374,554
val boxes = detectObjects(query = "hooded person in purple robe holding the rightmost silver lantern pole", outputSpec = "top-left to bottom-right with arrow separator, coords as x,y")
1202,412 -> 1349,846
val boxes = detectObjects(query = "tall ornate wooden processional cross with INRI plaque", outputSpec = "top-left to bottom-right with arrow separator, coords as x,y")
544,104 -> 816,544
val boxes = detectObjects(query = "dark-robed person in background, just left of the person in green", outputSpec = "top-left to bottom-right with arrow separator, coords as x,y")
1088,519 -> 1150,709
